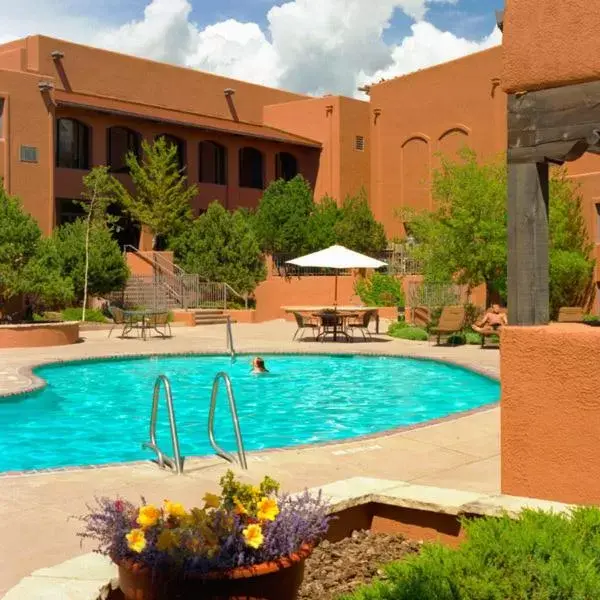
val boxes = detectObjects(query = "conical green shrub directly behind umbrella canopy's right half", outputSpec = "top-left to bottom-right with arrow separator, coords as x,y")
335,189 -> 387,254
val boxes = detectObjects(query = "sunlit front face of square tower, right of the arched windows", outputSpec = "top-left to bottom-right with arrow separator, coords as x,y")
263,96 -> 341,200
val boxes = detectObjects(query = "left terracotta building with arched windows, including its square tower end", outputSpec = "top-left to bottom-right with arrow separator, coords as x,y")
0,36 -> 370,245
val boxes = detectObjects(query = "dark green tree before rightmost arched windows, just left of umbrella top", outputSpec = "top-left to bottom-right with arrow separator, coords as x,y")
252,175 -> 315,255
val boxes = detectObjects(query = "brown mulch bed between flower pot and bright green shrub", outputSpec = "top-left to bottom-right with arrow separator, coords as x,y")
298,531 -> 421,600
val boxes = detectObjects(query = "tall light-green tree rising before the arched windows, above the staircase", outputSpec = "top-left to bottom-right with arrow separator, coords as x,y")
120,137 -> 198,249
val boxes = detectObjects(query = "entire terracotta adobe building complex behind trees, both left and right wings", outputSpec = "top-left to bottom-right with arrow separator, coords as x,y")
0,29 -> 600,304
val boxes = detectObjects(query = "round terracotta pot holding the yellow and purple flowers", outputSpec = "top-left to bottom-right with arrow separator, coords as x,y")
117,546 -> 312,600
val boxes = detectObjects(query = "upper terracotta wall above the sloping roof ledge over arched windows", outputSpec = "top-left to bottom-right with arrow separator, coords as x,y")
19,36 -> 305,123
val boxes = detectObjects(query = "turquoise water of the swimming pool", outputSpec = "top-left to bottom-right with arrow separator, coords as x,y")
0,355 -> 499,471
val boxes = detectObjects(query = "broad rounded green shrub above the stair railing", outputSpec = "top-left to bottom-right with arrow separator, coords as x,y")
172,201 -> 267,294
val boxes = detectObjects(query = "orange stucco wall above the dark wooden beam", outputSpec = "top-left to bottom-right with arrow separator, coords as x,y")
502,0 -> 600,92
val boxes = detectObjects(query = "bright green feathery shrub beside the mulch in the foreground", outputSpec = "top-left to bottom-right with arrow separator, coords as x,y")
350,507 -> 600,600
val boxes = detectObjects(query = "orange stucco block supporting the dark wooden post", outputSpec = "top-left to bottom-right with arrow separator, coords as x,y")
501,324 -> 600,504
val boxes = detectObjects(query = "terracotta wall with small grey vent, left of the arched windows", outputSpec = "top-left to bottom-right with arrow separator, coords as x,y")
0,70 -> 54,233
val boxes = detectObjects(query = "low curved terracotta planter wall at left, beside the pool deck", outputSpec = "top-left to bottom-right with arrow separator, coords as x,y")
0,321 -> 79,348
